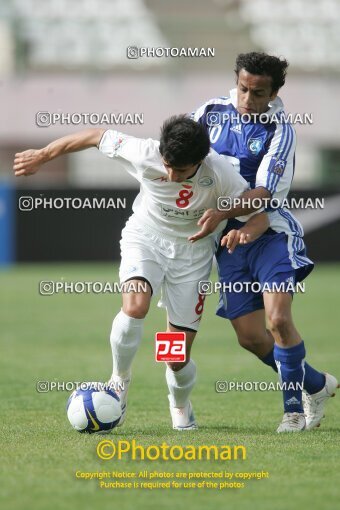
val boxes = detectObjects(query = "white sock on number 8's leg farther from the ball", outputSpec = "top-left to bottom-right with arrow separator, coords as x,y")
165,359 -> 196,407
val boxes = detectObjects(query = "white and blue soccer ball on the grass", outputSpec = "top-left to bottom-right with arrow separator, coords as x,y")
67,383 -> 122,434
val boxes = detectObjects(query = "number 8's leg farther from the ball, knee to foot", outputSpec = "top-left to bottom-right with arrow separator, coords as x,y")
166,323 -> 197,431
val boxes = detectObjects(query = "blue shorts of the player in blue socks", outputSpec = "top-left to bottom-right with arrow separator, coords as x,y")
216,229 -> 314,320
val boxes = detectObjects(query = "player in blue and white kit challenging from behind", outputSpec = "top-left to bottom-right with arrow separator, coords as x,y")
192,52 -> 338,432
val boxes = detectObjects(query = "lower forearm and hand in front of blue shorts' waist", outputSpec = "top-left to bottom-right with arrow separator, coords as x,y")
221,212 -> 269,253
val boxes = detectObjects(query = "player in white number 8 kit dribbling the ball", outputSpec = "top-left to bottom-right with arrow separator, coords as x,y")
14,116 -> 268,430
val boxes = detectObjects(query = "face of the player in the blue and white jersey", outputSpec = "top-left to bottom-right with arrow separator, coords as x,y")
237,69 -> 277,115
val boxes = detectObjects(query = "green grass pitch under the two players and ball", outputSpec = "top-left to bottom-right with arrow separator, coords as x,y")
0,264 -> 340,510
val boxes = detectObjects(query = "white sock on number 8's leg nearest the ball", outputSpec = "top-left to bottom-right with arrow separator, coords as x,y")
110,310 -> 144,379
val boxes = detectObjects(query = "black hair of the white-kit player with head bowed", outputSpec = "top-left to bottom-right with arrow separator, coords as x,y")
159,115 -> 210,168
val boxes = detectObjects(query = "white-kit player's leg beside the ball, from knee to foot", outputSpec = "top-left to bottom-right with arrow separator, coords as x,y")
109,279 -> 152,426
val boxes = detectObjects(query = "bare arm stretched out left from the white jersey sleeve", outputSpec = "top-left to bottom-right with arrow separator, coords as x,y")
13,129 -> 105,177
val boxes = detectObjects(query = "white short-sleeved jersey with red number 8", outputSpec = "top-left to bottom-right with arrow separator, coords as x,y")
98,130 -> 252,240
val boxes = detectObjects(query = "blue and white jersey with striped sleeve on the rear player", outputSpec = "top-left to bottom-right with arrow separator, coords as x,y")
192,89 -> 305,267
